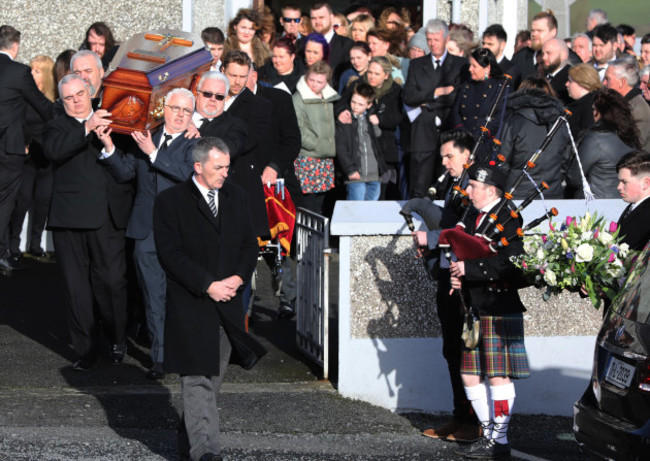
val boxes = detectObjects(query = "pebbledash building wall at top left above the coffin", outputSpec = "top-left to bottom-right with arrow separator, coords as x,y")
0,0 -> 225,63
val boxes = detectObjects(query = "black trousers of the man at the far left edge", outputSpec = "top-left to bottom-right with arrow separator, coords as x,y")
0,148 -> 27,258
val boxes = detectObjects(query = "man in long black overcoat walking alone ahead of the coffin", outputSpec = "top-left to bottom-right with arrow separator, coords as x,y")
154,137 -> 266,461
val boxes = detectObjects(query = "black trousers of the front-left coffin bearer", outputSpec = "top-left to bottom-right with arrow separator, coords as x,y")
53,214 -> 127,360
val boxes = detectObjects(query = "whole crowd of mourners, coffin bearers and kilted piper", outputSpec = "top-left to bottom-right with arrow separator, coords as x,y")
0,2 -> 650,461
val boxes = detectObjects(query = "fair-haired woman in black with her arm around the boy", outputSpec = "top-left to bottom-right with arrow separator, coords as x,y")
337,56 -> 403,199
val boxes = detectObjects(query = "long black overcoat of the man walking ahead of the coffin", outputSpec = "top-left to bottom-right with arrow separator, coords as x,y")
154,179 -> 266,376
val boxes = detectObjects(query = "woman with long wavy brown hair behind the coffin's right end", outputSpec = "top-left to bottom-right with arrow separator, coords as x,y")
223,8 -> 271,69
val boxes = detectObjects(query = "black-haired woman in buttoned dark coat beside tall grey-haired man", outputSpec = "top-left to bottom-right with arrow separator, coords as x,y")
449,48 -> 505,161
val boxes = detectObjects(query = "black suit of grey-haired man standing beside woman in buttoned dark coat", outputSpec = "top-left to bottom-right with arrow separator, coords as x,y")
402,53 -> 468,152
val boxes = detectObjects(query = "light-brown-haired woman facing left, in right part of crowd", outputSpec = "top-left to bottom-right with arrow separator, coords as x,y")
566,64 -> 603,138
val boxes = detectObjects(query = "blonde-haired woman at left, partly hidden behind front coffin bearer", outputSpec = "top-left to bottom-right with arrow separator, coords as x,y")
9,54 -> 54,261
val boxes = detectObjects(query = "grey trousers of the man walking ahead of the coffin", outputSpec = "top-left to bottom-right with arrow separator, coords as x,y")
181,327 -> 232,461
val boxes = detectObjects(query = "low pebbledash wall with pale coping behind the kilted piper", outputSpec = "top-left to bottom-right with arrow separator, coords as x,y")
331,200 -> 625,416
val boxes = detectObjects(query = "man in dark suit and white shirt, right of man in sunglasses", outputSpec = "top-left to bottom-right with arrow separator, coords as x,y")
310,2 -> 354,88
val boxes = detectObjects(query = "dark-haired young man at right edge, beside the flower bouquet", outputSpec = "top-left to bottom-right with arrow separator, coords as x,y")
616,150 -> 650,251
